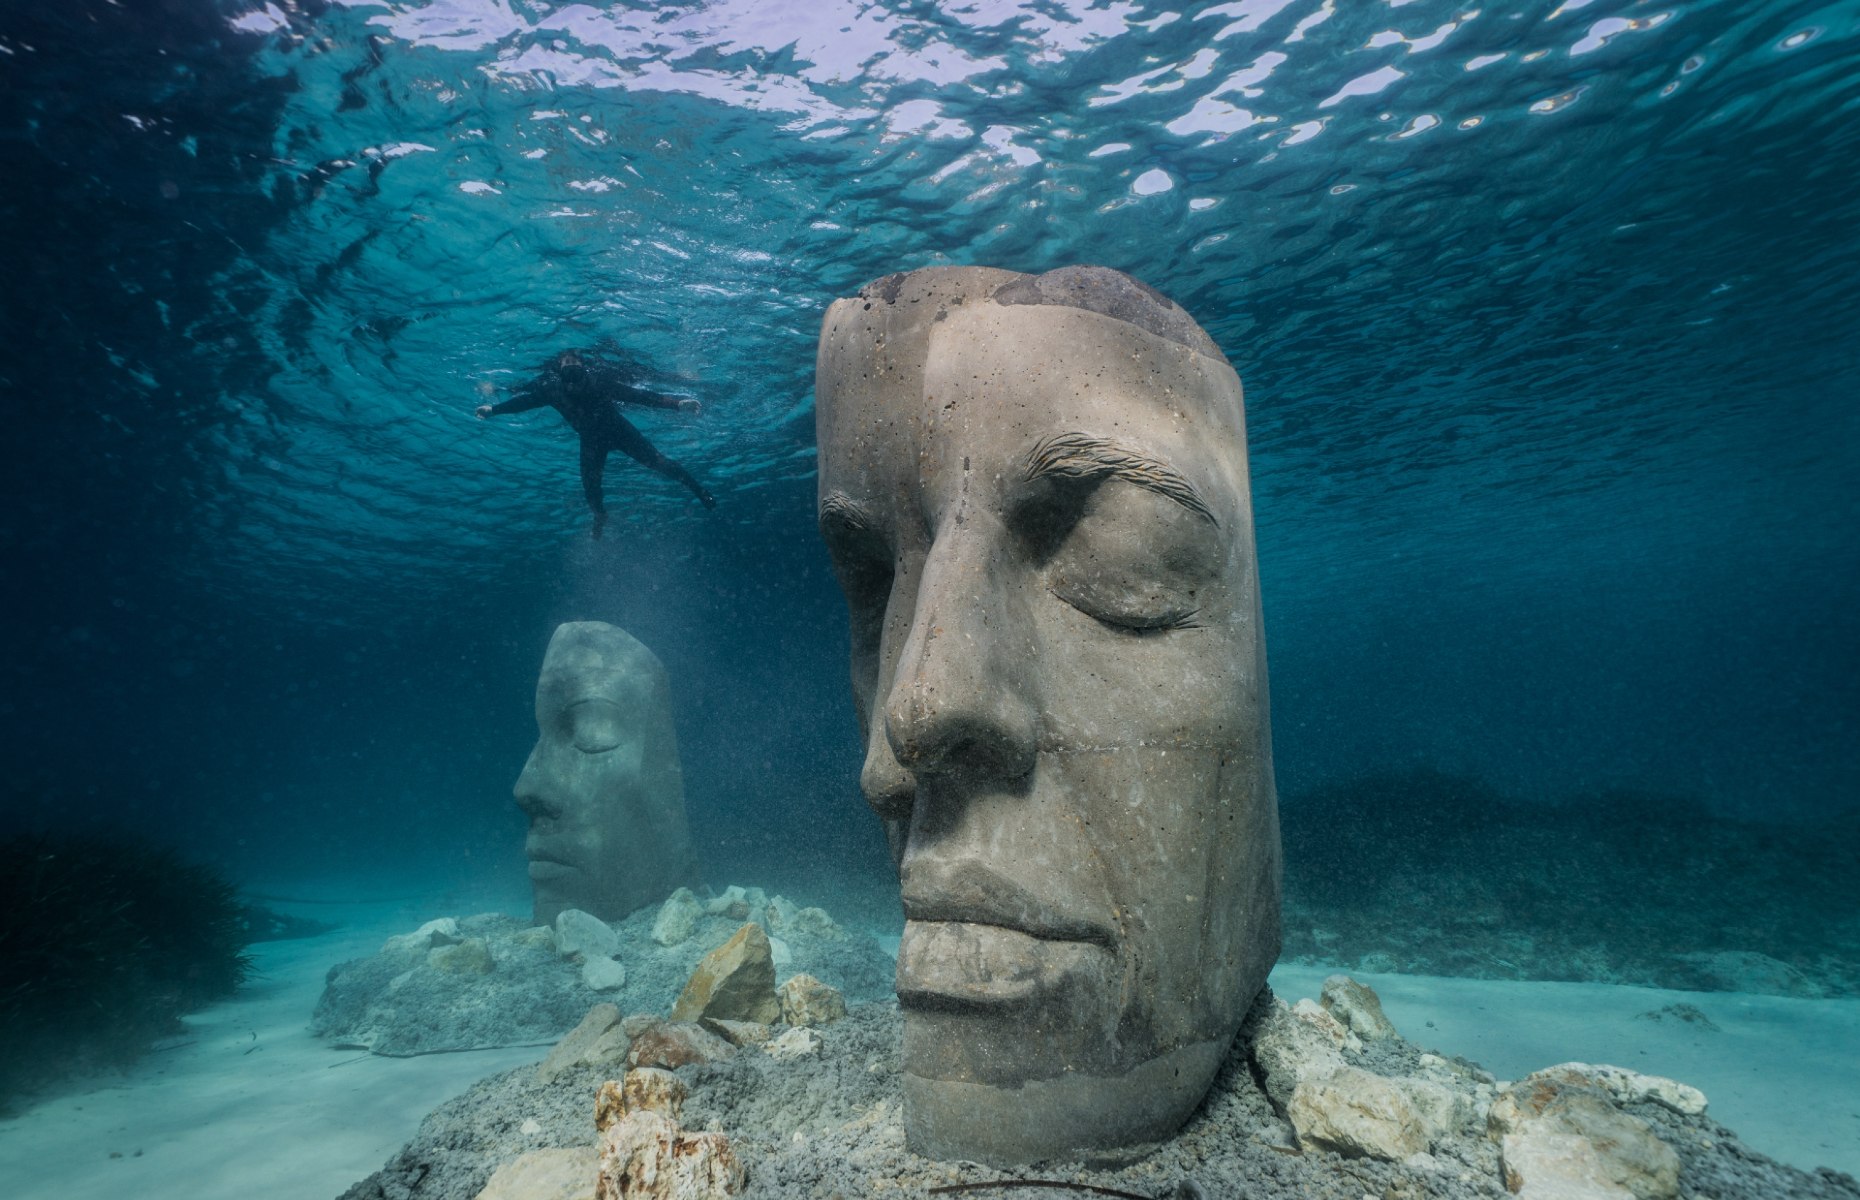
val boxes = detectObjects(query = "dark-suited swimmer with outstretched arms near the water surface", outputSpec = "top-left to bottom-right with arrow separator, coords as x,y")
476,350 -> 716,538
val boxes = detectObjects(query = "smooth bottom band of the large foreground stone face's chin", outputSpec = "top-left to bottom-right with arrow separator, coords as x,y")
904,1040 -> 1228,1167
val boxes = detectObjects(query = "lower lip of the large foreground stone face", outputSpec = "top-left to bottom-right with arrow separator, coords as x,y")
898,921 -> 1110,1012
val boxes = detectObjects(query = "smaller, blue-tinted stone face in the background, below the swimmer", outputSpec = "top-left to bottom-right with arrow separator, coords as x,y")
515,621 -> 698,925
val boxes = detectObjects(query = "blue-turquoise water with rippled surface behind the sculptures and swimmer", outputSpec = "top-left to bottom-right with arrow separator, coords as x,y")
0,0 -> 1860,967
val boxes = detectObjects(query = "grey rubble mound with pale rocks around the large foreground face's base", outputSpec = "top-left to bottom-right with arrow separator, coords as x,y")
346,977 -> 1860,1200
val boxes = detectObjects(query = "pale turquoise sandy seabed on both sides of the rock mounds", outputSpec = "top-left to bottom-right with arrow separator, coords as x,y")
0,895 -> 1860,1200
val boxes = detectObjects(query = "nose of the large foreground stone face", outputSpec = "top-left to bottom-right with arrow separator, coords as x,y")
867,538 -> 1038,796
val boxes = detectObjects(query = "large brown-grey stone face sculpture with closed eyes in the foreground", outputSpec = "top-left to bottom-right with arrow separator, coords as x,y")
817,268 -> 1280,1167
